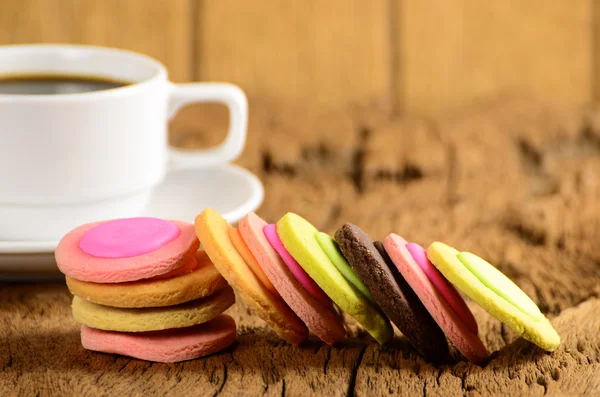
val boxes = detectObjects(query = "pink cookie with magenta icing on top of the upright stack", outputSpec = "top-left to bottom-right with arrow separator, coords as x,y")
55,218 -> 200,283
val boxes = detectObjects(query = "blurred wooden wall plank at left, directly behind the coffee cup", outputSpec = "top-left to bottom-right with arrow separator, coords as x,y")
0,0 -> 192,81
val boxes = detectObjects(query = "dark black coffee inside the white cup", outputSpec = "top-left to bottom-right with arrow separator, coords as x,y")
0,74 -> 131,95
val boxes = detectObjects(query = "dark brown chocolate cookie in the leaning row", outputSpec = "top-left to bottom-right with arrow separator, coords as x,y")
335,223 -> 449,362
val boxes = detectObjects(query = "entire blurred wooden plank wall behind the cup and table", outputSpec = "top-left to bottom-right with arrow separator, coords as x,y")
0,0 -> 600,116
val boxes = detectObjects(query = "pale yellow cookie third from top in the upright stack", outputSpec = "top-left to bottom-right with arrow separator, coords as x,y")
71,287 -> 235,332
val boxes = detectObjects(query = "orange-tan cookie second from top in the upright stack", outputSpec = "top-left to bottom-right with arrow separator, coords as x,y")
66,251 -> 227,308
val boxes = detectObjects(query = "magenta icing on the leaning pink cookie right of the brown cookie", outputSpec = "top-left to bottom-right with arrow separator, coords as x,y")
406,243 -> 479,335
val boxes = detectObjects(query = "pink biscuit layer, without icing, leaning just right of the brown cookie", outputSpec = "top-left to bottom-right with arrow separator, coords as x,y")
383,233 -> 488,363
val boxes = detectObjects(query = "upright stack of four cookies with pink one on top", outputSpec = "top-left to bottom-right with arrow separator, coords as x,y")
56,218 -> 236,362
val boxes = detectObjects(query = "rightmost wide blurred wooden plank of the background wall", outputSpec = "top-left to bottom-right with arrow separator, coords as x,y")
395,0 -> 598,115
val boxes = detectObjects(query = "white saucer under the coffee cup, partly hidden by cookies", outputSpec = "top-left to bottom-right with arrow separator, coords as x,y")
0,164 -> 264,274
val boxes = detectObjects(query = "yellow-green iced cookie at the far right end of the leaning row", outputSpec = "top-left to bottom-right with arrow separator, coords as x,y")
427,242 -> 560,351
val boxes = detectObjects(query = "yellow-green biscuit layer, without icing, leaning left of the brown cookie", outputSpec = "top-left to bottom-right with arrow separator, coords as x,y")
277,213 -> 394,344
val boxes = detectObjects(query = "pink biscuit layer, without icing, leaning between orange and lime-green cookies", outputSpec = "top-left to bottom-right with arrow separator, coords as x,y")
238,212 -> 345,345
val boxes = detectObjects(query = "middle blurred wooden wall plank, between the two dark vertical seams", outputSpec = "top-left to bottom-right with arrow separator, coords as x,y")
197,0 -> 391,107
